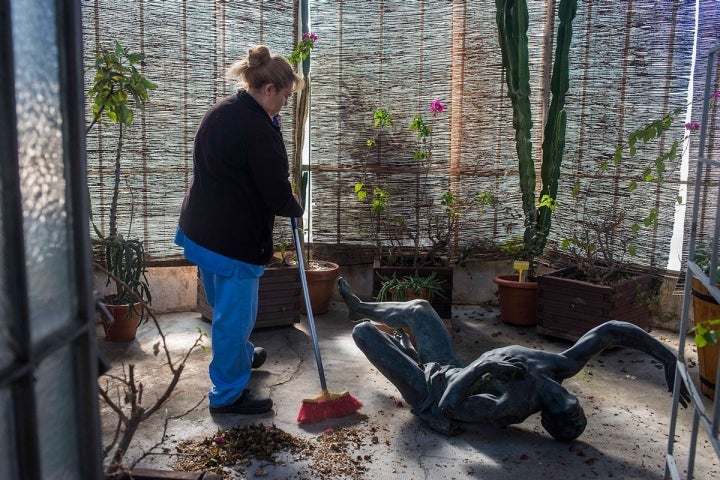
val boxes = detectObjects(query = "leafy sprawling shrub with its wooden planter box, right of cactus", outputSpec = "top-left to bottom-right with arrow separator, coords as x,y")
537,108 -> 681,340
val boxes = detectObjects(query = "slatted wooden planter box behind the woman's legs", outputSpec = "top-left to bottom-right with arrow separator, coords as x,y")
197,266 -> 303,328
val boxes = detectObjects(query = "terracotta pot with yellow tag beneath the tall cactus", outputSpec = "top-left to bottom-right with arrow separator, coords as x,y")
493,274 -> 537,326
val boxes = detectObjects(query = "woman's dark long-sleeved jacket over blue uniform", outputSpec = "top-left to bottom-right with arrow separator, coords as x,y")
180,90 -> 303,265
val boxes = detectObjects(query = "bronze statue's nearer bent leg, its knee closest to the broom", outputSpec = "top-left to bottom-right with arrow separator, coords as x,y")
353,322 -> 427,406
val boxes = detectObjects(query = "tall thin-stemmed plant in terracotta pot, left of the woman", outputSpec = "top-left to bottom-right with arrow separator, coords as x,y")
86,42 -> 157,341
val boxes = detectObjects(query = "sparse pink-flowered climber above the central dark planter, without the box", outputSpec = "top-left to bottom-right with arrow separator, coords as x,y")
353,100 -> 462,267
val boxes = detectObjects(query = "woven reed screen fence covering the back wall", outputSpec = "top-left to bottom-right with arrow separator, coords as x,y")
83,0 -> 720,274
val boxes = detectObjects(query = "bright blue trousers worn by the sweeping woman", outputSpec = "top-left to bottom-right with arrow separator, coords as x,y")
200,262 -> 264,407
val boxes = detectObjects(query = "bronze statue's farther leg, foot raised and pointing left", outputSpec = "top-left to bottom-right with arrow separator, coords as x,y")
338,278 -> 462,367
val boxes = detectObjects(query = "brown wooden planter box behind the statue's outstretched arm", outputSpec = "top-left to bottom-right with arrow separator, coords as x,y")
537,267 -> 653,341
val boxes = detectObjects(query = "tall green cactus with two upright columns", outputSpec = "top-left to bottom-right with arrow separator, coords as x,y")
495,0 -> 577,275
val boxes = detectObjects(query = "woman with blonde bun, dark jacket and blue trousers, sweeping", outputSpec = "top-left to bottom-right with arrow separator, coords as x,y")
175,45 -> 303,414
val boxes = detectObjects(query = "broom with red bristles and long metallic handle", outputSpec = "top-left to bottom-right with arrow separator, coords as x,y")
290,218 -> 362,423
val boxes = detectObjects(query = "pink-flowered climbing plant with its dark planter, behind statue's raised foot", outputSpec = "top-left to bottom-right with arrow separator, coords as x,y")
353,100 -> 494,318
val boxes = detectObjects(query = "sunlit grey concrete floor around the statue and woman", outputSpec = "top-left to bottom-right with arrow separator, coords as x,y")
100,298 -> 720,480
